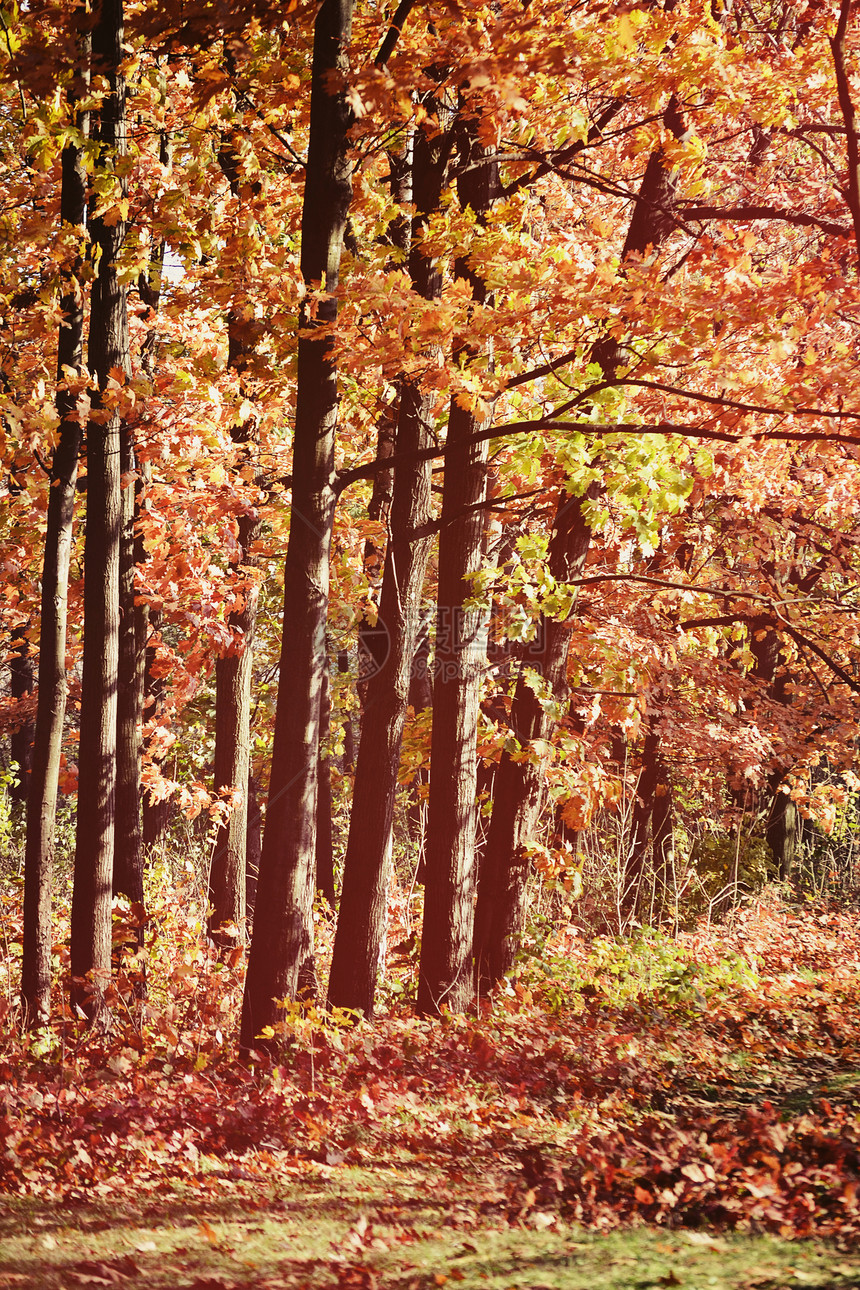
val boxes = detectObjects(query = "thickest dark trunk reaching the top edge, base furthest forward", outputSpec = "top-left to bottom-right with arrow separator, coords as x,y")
240,0 -> 353,1051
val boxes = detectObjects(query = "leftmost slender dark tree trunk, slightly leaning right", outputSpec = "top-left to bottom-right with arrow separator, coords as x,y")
21,17 -> 90,1026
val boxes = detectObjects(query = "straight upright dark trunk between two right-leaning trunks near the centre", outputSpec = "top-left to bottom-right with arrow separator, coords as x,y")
418,121 -> 499,1014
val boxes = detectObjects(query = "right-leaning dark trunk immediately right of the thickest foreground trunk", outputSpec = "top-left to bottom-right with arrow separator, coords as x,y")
329,116 -> 447,1017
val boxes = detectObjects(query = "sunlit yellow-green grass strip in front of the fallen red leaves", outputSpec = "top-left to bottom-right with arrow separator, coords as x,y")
0,1165 -> 860,1290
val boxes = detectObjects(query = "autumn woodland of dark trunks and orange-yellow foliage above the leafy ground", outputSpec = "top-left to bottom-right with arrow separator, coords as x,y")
0,0 -> 860,1284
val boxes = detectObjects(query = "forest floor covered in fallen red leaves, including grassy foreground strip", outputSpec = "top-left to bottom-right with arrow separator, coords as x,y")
0,897 -> 860,1290
